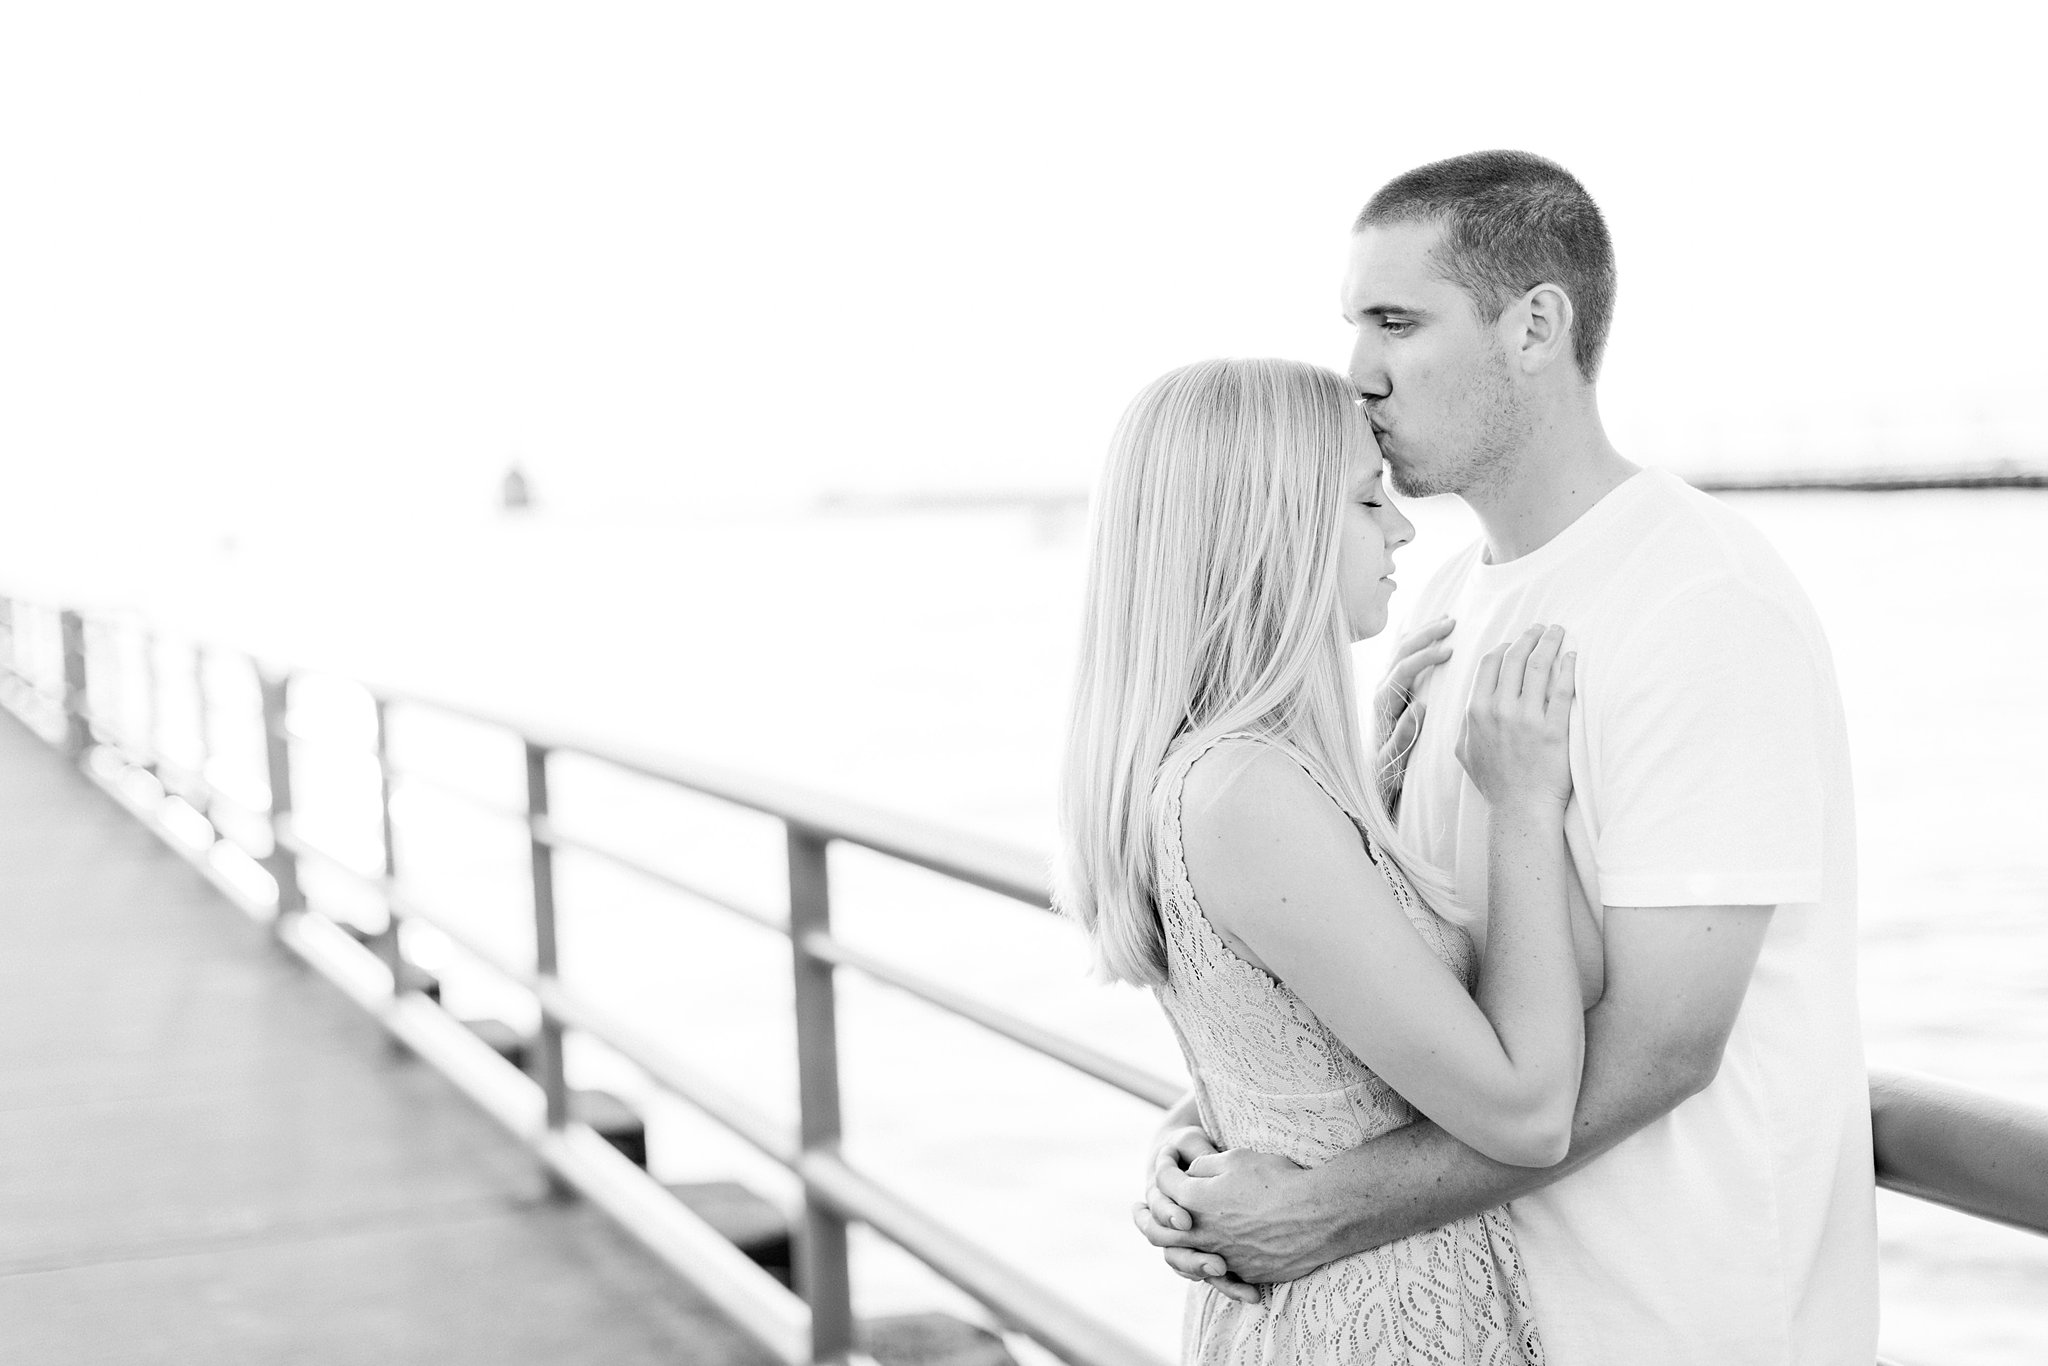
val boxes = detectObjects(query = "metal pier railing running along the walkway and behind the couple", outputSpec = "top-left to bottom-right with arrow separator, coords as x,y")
0,598 -> 2048,1366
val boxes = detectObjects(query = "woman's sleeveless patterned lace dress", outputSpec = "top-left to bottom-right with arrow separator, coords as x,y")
1157,735 -> 1544,1366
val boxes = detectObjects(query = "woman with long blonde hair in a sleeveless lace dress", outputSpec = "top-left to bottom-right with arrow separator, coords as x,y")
1061,360 -> 1583,1366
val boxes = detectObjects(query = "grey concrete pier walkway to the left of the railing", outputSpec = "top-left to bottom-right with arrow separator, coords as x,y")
0,713 -> 766,1366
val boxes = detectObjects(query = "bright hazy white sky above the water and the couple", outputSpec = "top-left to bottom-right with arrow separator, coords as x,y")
0,0 -> 2048,532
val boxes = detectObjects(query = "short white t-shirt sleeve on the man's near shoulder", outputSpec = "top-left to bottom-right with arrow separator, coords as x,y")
1589,584 -> 1829,905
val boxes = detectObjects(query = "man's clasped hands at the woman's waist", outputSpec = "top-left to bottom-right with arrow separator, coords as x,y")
1135,1149 -> 1335,1303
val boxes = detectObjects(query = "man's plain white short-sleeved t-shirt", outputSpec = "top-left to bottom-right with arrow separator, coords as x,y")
1401,471 -> 1878,1366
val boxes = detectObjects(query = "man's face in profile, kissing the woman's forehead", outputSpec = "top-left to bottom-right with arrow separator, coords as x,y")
1343,223 -> 1526,498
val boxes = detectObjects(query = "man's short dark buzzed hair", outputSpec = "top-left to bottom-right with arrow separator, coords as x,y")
1352,152 -> 1614,379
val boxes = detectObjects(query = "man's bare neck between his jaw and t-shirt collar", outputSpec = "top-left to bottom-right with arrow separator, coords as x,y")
1464,405 -> 1638,565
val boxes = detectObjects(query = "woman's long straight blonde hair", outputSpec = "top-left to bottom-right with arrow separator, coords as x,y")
1055,360 -> 1452,985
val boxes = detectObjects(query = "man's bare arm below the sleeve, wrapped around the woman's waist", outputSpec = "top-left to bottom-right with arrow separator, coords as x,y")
1139,905 -> 1772,1282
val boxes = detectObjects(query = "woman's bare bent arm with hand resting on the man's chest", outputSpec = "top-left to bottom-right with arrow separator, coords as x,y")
1184,629 -> 1583,1167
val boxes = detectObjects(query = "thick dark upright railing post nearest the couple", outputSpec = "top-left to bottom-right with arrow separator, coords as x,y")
788,823 -> 854,1362
